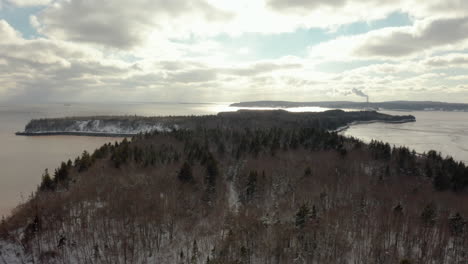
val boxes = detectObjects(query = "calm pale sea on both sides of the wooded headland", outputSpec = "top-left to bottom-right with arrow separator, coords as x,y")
0,103 -> 468,216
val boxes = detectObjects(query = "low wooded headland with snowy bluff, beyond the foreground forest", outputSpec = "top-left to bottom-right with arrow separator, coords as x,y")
16,110 -> 416,137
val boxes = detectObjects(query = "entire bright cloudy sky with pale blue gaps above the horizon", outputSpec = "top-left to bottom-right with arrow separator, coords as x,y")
0,0 -> 468,103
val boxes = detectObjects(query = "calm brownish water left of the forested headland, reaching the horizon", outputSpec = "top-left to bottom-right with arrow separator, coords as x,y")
0,104 -> 227,217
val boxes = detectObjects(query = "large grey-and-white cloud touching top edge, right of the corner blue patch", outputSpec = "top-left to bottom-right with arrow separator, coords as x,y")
37,0 -> 231,49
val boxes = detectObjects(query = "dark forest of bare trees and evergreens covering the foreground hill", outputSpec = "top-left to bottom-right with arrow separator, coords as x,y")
0,112 -> 468,264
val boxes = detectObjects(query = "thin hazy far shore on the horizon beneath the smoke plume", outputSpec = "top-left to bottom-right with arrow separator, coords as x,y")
230,101 -> 468,112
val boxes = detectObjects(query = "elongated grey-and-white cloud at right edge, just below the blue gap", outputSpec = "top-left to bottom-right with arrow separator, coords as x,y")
309,17 -> 468,60
